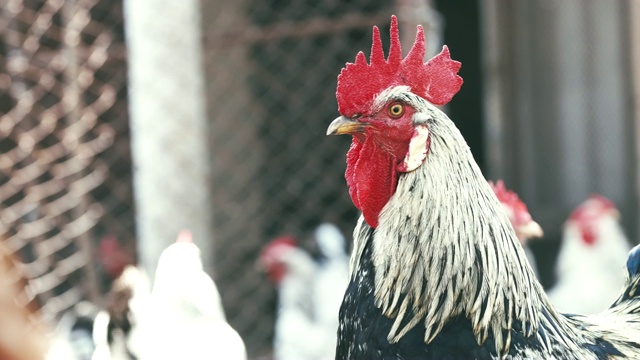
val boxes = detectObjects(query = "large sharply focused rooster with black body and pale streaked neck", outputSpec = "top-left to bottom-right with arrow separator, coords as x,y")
327,16 -> 640,359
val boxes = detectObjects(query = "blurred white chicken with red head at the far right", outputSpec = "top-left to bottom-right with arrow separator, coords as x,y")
548,195 -> 631,314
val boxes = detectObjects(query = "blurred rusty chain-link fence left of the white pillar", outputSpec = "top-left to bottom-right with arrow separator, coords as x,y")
0,0 -> 135,324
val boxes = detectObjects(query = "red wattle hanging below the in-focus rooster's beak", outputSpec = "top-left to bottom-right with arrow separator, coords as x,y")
345,137 -> 398,228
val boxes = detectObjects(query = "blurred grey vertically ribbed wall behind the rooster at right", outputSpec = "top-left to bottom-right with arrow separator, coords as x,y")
481,0 -> 637,285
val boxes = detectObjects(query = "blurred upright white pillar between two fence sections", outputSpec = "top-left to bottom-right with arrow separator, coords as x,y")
124,0 -> 213,275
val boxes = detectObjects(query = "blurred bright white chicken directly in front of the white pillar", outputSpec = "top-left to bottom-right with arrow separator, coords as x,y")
132,231 -> 246,360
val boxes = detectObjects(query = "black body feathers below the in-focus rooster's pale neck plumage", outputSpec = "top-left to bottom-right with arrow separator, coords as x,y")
336,230 -> 638,360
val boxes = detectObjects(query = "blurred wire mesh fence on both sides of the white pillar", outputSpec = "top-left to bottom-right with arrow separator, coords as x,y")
0,0 -> 430,357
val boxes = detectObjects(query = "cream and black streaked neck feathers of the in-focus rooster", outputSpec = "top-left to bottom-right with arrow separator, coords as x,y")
352,115 -> 555,351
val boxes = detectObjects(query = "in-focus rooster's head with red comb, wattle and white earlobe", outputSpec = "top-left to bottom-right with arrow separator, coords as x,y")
327,16 -> 462,228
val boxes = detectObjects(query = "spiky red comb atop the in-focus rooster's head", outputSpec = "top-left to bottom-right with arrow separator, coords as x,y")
336,15 -> 462,117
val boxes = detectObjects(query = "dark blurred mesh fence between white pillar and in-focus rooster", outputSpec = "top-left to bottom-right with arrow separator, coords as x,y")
204,0 -> 398,354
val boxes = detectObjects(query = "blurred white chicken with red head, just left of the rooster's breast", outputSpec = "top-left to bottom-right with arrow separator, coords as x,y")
260,224 -> 348,360
